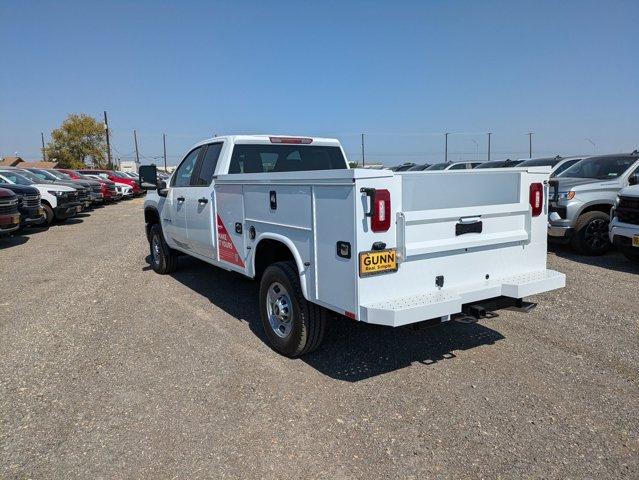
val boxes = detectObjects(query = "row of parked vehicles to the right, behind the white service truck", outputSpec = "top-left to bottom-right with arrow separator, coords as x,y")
391,150 -> 639,261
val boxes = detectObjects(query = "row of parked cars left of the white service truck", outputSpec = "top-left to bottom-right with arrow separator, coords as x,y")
0,167 -> 151,237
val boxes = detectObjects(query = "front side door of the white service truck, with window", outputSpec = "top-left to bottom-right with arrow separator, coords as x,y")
163,147 -> 202,251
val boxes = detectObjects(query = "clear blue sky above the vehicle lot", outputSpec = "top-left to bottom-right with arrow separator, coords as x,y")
0,0 -> 639,164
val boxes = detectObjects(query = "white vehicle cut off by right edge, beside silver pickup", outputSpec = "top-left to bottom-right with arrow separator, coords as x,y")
610,185 -> 639,262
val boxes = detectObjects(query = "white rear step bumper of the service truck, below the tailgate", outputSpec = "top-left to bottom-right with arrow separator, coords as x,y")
361,270 -> 566,327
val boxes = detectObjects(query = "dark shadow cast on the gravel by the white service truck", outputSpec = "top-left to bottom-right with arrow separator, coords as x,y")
159,257 -> 504,382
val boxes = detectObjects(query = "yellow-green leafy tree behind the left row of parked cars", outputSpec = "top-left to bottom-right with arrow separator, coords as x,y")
46,113 -> 107,168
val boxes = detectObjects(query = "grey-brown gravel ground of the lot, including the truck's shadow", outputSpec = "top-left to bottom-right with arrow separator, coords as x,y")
0,199 -> 639,479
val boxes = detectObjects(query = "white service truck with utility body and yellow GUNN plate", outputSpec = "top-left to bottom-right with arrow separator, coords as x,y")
140,135 -> 565,357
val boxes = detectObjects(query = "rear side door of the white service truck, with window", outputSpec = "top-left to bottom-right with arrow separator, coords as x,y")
186,142 -> 224,259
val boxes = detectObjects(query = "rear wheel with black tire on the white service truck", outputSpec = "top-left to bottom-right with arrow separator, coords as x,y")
260,261 -> 327,358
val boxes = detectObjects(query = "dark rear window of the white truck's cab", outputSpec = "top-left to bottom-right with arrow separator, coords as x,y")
229,144 -> 347,174
